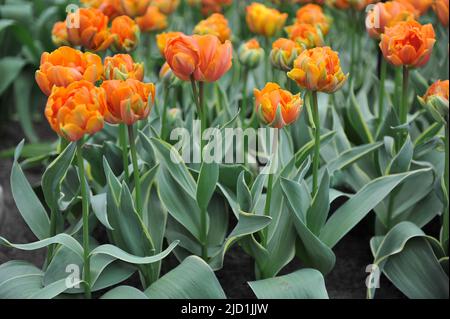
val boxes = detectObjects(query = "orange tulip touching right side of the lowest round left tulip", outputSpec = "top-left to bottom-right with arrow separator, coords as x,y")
102,79 -> 155,125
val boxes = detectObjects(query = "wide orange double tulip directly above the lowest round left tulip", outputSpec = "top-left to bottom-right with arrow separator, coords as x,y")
36,47 -> 103,95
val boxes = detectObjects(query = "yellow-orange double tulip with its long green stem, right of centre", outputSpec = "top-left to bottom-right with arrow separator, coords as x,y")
288,47 -> 348,197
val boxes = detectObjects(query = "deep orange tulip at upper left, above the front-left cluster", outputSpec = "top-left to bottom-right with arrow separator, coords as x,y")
67,8 -> 114,51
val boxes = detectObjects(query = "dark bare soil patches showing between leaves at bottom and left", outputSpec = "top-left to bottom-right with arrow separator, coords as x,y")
0,124 -> 405,299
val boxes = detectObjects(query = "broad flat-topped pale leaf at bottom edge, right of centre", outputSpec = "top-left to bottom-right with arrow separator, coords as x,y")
248,269 -> 328,299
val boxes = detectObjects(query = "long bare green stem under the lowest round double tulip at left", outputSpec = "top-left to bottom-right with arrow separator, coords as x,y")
77,140 -> 91,299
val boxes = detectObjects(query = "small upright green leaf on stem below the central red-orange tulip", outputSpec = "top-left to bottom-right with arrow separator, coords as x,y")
196,162 -> 219,211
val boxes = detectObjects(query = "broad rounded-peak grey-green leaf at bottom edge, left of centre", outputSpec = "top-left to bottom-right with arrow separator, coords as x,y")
145,256 -> 226,299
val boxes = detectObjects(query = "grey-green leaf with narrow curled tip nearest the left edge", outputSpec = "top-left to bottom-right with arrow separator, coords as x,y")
11,141 -> 50,239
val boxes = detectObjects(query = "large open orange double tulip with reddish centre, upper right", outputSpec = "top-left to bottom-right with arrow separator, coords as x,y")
380,20 -> 436,68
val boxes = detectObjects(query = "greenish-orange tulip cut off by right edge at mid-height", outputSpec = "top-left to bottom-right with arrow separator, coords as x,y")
418,80 -> 449,124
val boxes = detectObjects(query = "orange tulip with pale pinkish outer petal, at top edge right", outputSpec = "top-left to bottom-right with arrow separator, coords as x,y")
366,1 -> 418,39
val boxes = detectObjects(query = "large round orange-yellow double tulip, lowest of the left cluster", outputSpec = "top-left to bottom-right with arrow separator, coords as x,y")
45,81 -> 107,142
